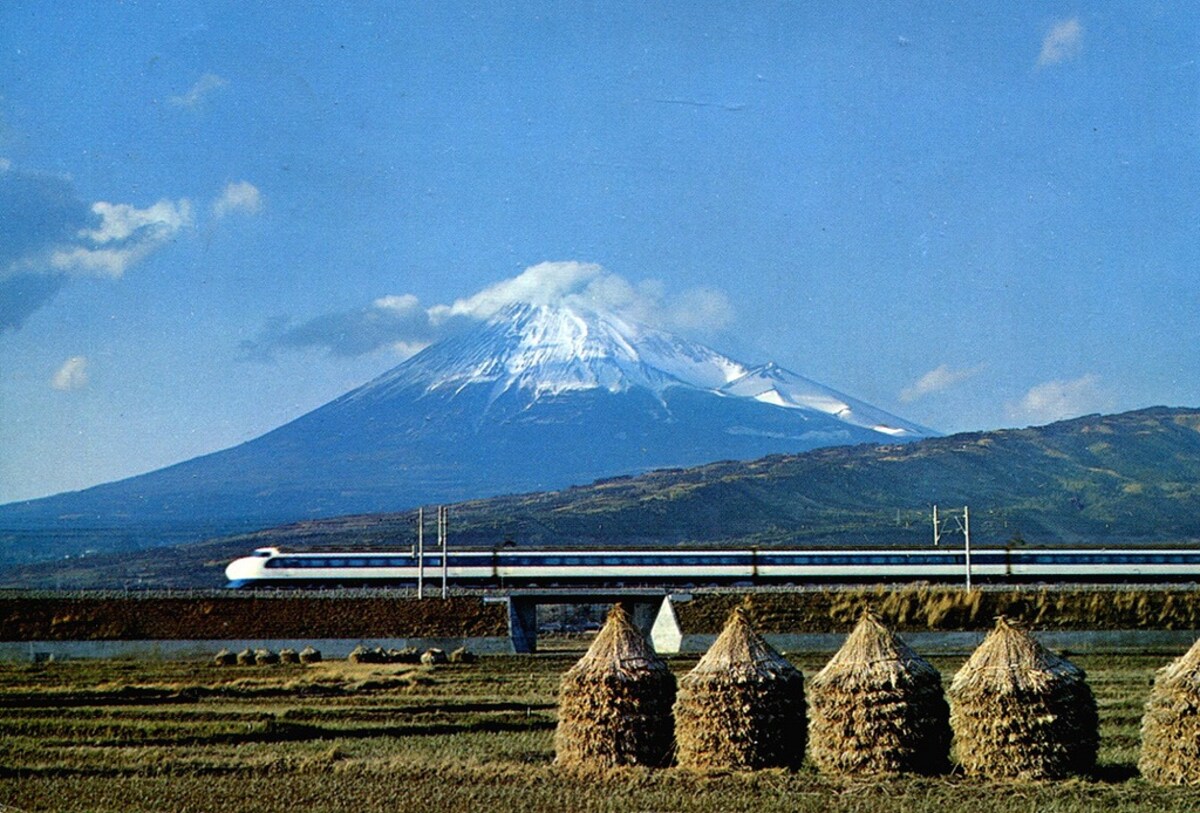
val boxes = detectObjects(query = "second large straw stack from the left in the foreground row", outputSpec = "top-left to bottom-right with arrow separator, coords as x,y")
674,608 -> 806,770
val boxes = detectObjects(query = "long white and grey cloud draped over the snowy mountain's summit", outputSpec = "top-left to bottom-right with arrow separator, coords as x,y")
242,261 -> 734,359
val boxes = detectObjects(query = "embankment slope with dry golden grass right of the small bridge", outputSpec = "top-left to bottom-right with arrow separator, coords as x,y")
674,586 -> 1200,634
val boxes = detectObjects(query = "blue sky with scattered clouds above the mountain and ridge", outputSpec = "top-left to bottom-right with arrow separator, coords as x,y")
0,0 -> 1200,501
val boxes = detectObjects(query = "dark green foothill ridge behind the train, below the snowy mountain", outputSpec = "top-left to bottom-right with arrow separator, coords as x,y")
4,407 -> 1200,586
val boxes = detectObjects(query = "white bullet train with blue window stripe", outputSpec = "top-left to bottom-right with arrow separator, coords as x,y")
226,548 -> 1200,588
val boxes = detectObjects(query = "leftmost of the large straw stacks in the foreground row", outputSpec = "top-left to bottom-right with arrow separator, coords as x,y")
554,604 -> 676,769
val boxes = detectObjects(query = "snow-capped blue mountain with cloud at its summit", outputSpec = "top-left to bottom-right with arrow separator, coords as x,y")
0,305 -> 936,561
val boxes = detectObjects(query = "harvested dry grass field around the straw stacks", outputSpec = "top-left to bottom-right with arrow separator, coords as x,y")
0,652 -> 1200,813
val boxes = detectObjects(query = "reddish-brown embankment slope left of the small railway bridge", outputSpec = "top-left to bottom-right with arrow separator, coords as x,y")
0,594 -> 508,642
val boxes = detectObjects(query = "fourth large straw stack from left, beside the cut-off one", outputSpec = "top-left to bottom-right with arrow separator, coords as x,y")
949,619 -> 1099,779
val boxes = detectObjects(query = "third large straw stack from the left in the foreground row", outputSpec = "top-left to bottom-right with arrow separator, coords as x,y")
809,612 -> 950,776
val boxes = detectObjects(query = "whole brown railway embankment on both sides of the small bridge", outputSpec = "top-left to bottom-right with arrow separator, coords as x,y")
0,585 -> 1200,642
